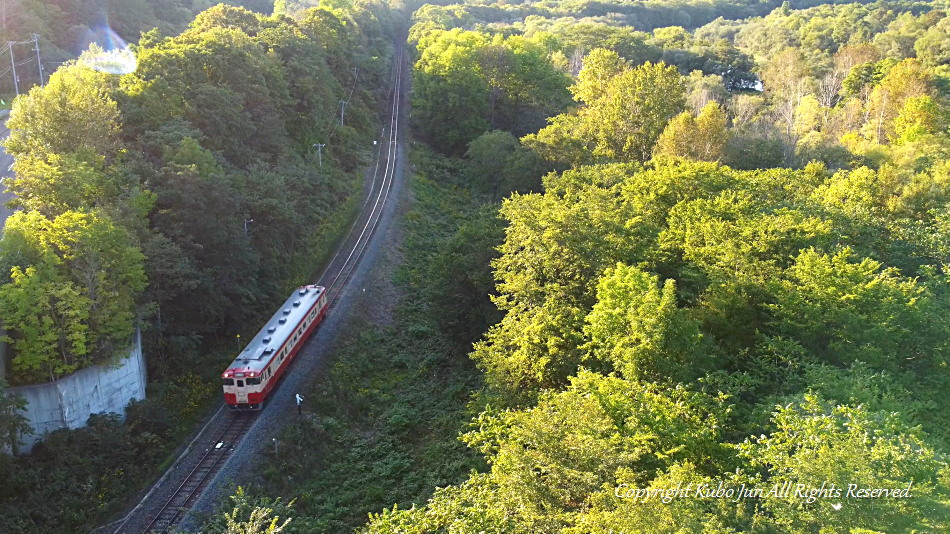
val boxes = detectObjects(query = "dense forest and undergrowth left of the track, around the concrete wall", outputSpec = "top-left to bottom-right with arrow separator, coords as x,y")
0,2 -> 392,532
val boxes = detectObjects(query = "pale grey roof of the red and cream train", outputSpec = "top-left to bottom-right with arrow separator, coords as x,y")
224,285 -> 326,375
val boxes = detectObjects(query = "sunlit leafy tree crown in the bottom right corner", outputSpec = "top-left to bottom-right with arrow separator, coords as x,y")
739,394 -> 950,532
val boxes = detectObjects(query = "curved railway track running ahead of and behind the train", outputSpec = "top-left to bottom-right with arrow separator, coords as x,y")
97,38 -> 405,534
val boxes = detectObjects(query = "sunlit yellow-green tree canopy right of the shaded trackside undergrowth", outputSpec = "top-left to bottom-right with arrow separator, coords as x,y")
364,6 -> 950,534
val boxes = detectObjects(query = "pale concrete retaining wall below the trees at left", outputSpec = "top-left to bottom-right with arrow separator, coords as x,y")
7,332 -> 146,452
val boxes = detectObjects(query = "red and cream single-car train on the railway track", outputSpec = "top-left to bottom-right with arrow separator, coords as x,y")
221,285 -> 327,410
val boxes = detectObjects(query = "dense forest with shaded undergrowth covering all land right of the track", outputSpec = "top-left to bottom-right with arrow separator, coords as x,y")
209,2 -> 950,534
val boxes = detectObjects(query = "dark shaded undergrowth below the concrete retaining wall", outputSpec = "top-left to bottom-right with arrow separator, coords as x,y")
0,391 -> 204,534
